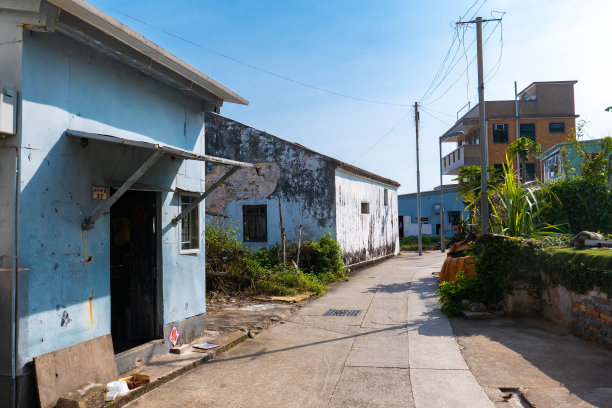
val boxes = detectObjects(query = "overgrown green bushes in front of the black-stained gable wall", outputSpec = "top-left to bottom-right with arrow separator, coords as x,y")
206,223 -> 345,296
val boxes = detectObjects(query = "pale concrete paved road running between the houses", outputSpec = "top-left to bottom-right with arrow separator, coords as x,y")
128,252 -> 493,408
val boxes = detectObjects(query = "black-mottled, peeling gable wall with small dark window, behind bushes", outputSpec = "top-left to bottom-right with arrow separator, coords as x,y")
206,113 -> 336,246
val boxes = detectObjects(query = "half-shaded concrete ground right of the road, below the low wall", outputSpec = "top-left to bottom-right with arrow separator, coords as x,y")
451,318 -> 612,407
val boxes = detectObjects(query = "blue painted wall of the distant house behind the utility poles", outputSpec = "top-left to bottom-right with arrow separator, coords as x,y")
397,188 -> 468,237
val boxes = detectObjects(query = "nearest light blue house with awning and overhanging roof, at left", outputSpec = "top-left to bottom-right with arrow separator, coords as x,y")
0,0 -> 251,406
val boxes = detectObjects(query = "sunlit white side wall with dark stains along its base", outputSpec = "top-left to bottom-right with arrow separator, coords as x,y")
335,169 -> 399,265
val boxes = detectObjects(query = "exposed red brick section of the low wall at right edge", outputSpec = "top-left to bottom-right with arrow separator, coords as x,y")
569,291 -> 612,350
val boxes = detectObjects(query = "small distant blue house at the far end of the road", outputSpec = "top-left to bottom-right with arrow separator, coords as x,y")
397,185 -> 468,237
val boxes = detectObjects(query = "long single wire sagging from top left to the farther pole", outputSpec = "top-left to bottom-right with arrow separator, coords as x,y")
88,0 -> 412,107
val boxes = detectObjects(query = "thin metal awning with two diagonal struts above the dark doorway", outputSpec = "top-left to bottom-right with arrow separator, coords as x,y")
66,129 -> 253,230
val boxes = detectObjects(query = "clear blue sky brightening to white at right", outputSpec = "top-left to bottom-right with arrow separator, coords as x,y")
88,0 -> 612,193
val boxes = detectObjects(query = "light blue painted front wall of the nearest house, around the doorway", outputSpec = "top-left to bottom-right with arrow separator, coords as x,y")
19,29 -> 206,364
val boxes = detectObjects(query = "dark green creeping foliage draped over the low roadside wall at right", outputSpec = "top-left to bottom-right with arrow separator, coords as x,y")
437,235 -> 612,316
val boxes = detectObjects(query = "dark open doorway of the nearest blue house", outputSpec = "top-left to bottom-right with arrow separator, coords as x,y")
110,191 -> 159,353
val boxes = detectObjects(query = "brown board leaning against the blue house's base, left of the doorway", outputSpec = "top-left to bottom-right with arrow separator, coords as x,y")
34,334 -> 117,408
